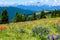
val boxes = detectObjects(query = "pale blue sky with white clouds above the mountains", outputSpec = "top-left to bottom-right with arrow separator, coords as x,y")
0,0 -> 60,6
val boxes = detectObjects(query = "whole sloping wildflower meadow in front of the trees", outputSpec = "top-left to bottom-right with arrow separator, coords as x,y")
0,18 -> 60,40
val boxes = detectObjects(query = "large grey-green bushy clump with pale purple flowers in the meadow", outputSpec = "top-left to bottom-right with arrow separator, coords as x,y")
32,27 -> 50,36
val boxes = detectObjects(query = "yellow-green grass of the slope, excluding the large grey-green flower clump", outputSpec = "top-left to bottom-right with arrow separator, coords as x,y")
0,18 -> 60,40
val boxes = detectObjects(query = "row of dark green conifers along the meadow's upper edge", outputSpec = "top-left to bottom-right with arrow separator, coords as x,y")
0,9 -> 60,24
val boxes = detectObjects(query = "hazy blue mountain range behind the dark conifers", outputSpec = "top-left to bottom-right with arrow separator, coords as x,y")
0,5 -> 60,20
